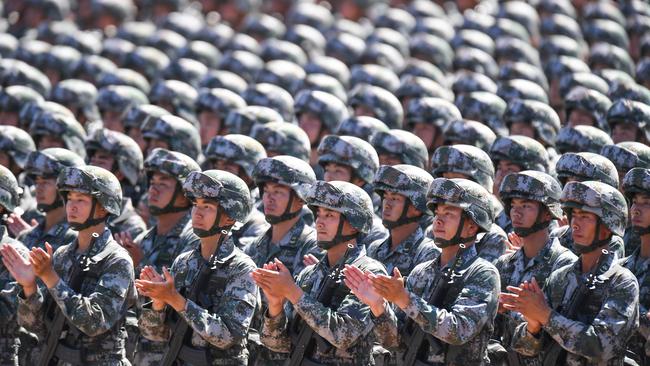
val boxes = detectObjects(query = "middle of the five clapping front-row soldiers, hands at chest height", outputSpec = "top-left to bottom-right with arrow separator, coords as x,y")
253,181 -> 394,365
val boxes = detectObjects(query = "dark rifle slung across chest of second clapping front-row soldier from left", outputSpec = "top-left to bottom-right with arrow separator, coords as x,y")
162,239 -> 225,366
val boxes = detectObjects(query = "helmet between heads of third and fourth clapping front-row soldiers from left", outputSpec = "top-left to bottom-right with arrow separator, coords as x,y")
373,164 -> 433,213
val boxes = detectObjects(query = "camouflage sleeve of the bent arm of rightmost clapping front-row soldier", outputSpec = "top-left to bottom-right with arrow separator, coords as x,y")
543,276 -> 639,363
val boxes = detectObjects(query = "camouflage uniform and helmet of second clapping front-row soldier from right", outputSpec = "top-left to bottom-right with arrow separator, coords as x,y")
375,178 -> 500,365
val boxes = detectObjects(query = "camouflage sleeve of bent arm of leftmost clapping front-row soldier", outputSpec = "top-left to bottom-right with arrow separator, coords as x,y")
48,257 -> 133,337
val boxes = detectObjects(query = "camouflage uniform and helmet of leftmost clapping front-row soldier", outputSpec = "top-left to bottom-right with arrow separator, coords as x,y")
18,166 -> 137,365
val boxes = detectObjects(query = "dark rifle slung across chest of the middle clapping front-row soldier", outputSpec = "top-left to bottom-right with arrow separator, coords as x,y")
288,244 -> 354,366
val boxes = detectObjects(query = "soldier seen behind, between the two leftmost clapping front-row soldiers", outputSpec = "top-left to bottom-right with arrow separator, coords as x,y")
86,129 -> 147,238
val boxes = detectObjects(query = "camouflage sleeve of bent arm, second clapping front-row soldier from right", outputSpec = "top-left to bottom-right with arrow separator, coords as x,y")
404,265 -> 500,345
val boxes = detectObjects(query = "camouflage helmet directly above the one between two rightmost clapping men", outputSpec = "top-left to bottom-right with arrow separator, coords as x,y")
490,135 -> 549,172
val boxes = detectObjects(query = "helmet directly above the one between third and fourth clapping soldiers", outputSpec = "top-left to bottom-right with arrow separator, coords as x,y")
370,130 -> 429,169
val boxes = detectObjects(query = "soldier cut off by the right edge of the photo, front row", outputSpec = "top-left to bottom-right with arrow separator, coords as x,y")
621,168 -> 650,365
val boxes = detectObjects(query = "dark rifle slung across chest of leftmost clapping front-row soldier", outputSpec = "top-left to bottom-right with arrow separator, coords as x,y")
38,233 -> 99,366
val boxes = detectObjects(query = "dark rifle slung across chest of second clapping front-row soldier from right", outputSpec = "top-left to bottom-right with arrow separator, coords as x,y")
402,244 -> 467,366
